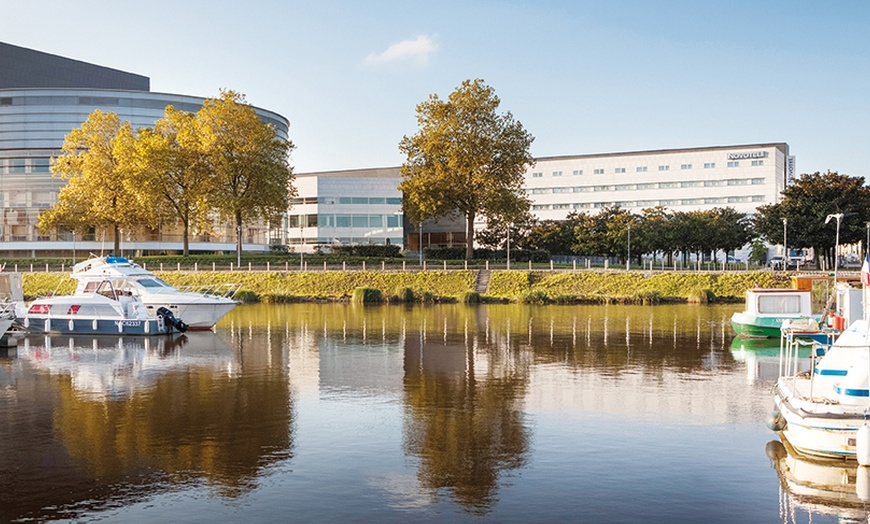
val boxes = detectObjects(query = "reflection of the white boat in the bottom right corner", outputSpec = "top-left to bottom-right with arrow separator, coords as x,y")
765,440 -> 870,522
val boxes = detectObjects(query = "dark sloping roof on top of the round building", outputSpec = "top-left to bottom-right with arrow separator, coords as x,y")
0,42 -> 151,91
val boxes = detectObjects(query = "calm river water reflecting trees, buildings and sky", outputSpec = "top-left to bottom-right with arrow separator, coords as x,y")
0,304 -> 867,523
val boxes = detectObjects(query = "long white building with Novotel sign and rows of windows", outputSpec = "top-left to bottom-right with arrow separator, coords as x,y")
525,143 -> 794,220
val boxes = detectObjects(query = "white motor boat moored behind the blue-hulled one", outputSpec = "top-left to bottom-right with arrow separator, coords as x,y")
71,256 -> 240,331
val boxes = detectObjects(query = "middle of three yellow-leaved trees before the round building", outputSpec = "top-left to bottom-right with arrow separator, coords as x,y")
124,106 -> 215,256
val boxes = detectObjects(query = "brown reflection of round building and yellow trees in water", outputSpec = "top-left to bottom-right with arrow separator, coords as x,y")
0,332 -> 293,520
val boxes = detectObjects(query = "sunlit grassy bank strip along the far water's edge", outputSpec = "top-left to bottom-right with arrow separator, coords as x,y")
17,270 -> 790,304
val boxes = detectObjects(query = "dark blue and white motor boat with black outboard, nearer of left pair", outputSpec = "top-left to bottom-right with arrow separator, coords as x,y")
17,279 -> 187,335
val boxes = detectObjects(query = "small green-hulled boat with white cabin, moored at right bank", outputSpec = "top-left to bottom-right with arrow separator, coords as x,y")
731,288 -> 820,338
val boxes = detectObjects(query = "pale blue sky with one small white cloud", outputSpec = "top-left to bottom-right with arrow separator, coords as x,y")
0,0 -> 870,180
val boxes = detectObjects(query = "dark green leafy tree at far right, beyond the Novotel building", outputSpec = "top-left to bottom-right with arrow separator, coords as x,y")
754,171 -> 870,262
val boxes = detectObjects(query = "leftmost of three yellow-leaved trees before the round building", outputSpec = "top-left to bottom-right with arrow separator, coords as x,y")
37,110 -> 145,254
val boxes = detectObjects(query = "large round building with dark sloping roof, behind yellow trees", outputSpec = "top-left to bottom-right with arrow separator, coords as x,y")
0,43 -> 289,256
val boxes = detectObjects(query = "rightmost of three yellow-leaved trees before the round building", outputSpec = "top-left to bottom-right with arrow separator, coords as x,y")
196,91 -> 296,262
